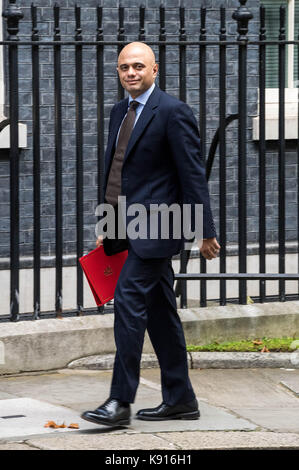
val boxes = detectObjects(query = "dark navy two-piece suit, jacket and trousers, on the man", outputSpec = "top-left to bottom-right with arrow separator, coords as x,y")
104,86 -> 216,405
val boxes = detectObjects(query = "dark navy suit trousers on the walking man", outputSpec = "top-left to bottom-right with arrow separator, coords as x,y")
110,243 -> 195,406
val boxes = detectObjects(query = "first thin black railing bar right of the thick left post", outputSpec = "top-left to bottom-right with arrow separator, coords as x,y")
31,4 -> 41,319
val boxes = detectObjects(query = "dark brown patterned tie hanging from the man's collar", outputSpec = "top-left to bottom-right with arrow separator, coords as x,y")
105,100 -> 139,206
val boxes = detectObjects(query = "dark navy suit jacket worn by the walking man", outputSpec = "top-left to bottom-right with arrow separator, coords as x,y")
104,86 -> 216,258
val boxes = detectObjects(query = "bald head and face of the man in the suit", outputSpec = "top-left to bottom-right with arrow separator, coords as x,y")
117,47 -> 158,98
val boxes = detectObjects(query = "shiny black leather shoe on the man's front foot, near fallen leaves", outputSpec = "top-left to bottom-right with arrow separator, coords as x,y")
81,398 -> 131,426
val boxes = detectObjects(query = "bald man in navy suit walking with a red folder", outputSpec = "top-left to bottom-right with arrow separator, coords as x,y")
82,42 -> 220,426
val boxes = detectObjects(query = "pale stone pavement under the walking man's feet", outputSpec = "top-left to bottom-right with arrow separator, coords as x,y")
0,368 -> 299,452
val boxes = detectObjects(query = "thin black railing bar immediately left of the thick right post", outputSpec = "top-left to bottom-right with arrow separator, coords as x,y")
219,5 -> 227,305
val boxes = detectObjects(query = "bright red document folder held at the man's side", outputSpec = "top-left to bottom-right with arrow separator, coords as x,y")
79,245 -> 128,306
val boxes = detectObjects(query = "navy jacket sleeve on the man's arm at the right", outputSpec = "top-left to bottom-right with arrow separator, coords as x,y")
167,102 -> 216,238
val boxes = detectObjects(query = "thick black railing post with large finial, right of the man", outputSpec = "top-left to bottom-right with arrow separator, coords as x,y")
233,0 -> 252,304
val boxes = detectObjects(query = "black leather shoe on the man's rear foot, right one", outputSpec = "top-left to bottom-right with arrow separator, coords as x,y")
136,398 -> 200,421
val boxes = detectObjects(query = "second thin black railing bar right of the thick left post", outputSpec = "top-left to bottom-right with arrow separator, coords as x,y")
54,3 -> 63,317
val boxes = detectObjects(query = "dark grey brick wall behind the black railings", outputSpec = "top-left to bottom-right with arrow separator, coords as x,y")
0,0 -> 297,256
